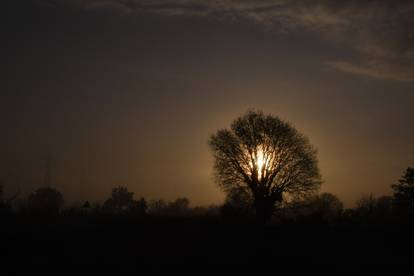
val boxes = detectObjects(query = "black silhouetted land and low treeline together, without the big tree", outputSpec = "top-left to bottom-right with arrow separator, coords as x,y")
0,169 -> 414,273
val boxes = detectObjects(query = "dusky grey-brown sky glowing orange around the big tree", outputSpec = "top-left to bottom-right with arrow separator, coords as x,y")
0,0 -> 414,206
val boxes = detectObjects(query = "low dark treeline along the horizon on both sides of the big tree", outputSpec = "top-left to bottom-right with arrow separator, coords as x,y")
0,168 -> 414,225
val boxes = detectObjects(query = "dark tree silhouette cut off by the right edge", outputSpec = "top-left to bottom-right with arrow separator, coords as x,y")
392,167 -> 414,213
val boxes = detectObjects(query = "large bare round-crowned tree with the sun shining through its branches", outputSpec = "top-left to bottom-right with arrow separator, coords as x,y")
209,111 -> 321,223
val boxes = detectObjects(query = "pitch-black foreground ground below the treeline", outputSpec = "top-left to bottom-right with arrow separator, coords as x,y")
0,213 -> 414,275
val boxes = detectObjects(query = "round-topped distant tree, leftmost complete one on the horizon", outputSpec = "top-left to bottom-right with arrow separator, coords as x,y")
27,187 -> 63,215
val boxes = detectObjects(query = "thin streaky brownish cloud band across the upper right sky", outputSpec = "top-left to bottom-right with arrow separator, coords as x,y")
43,0 -> 414,81
